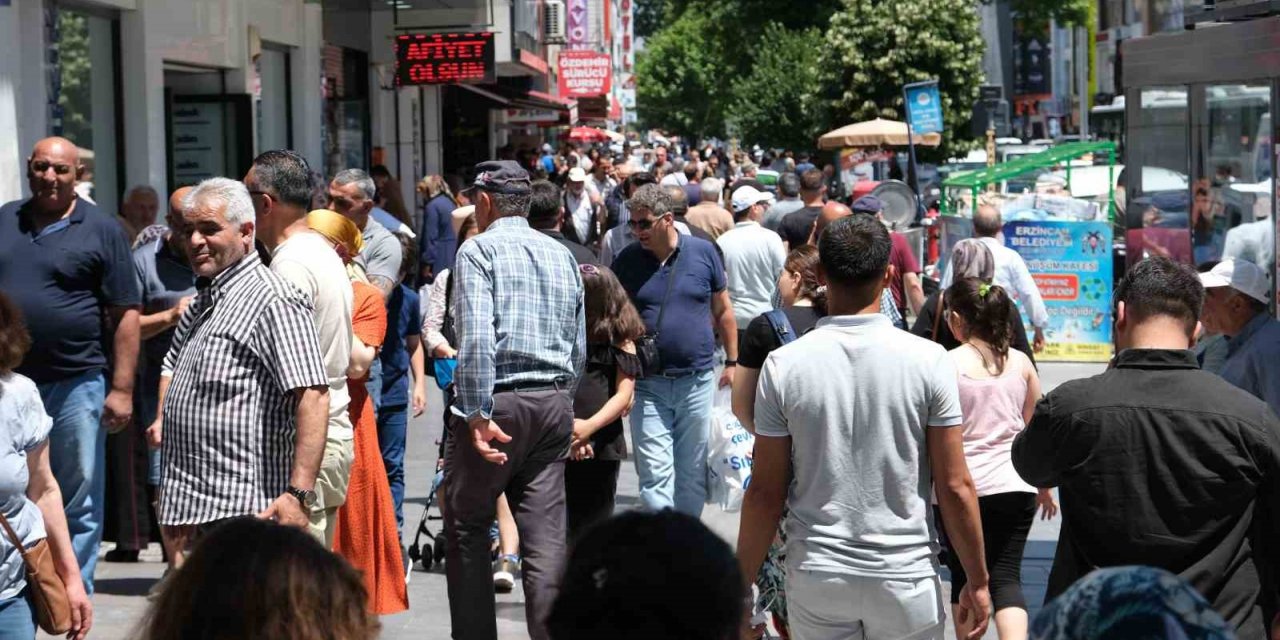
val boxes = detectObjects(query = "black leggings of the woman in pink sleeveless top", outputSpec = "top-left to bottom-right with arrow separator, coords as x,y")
933,492 -> 1036,611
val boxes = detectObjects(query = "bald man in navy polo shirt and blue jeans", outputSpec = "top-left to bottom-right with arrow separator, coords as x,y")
0,138 -> 141,594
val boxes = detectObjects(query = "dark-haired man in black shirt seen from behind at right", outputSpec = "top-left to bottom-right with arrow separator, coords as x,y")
1012,259 -> 1280,640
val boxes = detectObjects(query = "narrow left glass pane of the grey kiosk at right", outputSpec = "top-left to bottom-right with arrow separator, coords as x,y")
1131,87 -> 1192,266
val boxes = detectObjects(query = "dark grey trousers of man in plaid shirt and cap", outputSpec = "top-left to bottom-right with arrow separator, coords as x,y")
444,389 -> 573,640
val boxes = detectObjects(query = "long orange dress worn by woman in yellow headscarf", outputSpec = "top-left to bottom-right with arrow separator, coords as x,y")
333,282 -> 408,614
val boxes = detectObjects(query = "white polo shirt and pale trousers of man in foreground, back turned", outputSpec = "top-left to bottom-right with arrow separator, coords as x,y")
755,314 -> 963,637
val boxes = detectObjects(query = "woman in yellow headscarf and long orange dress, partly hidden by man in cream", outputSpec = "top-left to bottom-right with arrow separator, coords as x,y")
307,210 -> 408,614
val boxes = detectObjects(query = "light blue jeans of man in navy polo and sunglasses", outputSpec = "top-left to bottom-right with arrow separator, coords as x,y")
631,370 -> 716,517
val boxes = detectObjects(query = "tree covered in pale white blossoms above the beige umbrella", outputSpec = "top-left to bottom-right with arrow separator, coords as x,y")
819,0 -> 984,160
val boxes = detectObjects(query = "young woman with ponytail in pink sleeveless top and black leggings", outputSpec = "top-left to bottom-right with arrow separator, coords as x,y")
938,278 -> 1057,640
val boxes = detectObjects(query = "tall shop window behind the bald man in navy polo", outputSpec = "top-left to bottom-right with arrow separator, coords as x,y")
45,6 -> 122,214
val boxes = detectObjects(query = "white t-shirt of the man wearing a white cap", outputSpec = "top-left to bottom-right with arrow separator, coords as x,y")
716,220 -> 787,330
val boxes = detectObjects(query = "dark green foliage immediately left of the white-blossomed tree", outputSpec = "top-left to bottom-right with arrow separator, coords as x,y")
727,23 -> 823,148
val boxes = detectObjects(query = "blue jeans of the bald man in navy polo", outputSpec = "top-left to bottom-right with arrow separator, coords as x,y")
40,371 -> 106,594
